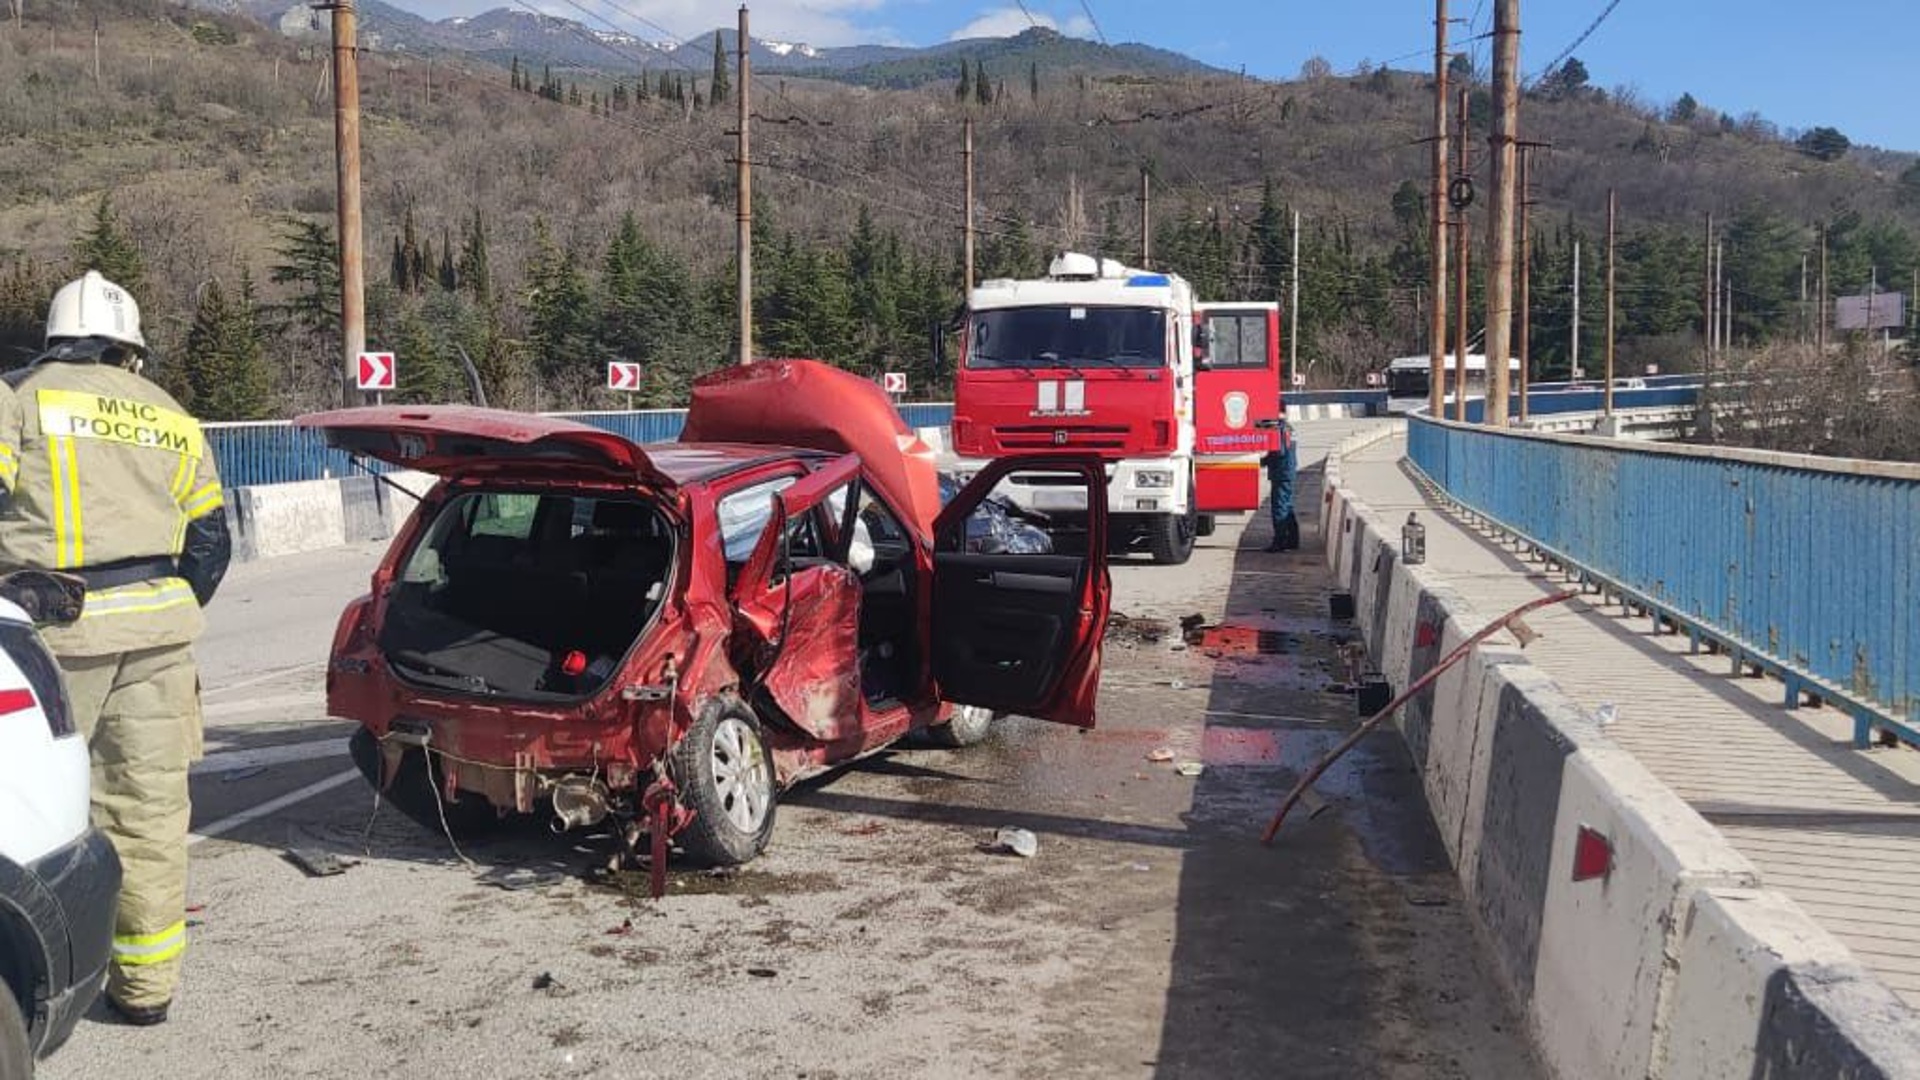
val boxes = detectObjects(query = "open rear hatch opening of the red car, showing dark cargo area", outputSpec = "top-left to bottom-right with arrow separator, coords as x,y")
380,492 -> 674,698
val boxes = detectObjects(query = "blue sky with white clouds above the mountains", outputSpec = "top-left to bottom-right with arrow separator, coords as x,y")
392,0 -> 1920,150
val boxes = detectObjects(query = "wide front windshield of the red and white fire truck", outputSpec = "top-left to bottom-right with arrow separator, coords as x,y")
966,306 -> 1167,371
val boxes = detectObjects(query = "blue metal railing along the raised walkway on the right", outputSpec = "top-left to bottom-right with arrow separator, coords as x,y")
1407,407 -> 1920,746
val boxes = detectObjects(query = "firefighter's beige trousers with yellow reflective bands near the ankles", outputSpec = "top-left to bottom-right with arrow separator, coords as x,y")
60,644 -> 202,1007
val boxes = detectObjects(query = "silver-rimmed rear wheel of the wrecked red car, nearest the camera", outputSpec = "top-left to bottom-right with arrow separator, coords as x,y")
670,701 -> 780,867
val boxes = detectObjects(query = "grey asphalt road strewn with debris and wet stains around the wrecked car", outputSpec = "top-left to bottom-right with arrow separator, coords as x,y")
40,423 -> 1540,1080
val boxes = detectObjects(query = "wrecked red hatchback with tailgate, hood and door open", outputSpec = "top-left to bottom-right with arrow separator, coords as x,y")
294,361 -> 1110,865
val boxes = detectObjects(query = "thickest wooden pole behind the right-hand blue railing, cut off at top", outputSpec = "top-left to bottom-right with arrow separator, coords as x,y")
1484,0 -> 1521,427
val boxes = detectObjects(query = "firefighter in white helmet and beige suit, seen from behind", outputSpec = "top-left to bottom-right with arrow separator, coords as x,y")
0,271 -> 230,1024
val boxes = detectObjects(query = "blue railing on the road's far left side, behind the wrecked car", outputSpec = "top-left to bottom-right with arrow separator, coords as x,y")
205,402 -> 954,488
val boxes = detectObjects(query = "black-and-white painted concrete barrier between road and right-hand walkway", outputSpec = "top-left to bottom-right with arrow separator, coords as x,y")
1323,425 -> 1920,1080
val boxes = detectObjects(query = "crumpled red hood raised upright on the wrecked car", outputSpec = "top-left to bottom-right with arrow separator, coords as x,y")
680,359 -> 941,540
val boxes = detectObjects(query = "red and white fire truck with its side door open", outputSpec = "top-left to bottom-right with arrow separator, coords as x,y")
952,254 -> 1281,563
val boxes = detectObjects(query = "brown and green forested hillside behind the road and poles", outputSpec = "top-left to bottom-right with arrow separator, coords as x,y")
0,0 -> 1920,417
